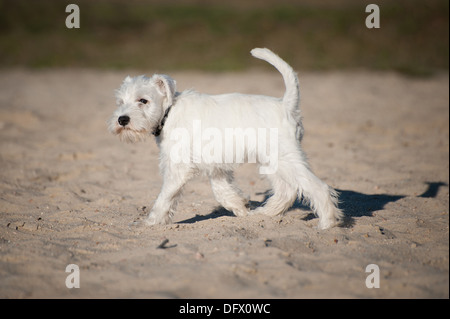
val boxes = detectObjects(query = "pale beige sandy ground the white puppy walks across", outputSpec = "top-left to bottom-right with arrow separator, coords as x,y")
0,70 -> 449,298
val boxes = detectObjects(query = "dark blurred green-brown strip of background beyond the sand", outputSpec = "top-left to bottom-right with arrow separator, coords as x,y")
0,0 -> 449,76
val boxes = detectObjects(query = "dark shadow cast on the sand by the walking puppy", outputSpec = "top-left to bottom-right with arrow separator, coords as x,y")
178,182 -> 448,228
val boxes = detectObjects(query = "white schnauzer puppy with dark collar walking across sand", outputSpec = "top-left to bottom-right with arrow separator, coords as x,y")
109,48 -> 343,229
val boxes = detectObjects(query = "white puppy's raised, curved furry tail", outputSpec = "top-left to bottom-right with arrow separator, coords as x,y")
250,48 -> 300,113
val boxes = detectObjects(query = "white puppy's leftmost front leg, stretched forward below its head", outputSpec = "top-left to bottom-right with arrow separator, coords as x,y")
145,168 -> 192,225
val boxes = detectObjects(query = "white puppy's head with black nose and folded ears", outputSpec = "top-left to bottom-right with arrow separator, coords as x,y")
109,74 -> 176,143
